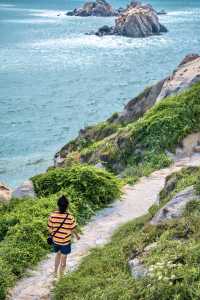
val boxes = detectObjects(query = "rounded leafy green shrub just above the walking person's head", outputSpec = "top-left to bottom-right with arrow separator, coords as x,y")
32,165 -> 120,205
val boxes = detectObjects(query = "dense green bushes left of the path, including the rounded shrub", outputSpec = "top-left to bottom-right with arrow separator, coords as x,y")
0,165 -> 120,299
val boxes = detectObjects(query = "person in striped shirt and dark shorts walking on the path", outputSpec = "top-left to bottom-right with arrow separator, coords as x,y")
48,196 -> 80,275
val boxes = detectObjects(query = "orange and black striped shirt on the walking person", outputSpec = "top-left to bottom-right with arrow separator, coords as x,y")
48,211 -> 76,245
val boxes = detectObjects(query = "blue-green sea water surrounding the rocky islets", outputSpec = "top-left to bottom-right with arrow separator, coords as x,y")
0,0 -> 200,187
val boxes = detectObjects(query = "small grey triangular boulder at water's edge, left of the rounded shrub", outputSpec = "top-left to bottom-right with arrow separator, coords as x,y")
12,180 -> 36,199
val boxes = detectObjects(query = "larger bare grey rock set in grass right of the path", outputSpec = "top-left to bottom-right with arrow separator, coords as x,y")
150,186 -> 199,225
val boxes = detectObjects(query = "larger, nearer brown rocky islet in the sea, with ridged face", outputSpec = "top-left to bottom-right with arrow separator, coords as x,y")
96,2 -> 167,38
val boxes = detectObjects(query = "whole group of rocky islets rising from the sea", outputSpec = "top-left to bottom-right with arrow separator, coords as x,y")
67,0 -> 167,37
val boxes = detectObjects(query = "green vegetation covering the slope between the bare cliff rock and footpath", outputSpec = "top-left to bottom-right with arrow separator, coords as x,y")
59,83 -> 200,180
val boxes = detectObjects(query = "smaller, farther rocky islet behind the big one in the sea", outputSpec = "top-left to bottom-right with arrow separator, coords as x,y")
67,0 -> 119,17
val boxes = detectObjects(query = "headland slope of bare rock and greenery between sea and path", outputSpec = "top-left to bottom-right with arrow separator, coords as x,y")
55,55 -> 200,180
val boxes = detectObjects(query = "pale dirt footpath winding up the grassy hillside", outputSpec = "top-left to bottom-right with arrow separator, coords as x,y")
9,155 -> 200,300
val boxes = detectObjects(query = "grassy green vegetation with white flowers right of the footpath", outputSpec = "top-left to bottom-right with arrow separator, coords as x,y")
54,168 -> 200,300
